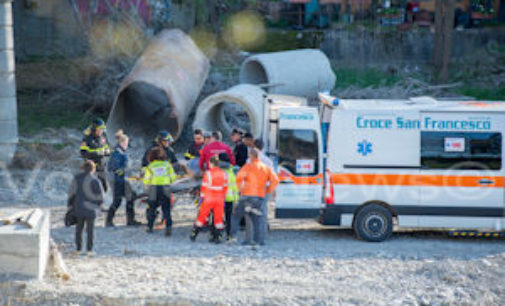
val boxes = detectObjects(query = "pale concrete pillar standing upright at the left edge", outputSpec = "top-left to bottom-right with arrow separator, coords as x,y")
0,0 -> 18,163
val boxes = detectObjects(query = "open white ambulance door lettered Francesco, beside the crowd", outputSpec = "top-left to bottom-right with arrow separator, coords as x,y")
267,97 -> 324,218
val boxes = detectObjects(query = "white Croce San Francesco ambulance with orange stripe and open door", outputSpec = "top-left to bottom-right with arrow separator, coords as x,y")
264,94 -> 505,241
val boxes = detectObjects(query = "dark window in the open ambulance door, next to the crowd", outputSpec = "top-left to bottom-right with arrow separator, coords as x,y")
277,129 -> 319,175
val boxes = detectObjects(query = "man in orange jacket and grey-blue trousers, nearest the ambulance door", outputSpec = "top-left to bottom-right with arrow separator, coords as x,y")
230,148 -> 279,245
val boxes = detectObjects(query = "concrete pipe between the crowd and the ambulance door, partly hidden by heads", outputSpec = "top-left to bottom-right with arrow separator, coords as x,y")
193,84 -> 266,136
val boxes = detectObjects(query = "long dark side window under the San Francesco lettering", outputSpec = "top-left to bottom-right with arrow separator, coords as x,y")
421,132 -> 502,170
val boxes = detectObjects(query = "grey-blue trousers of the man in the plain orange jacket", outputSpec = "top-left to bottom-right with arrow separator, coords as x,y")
231,196 -> 266,244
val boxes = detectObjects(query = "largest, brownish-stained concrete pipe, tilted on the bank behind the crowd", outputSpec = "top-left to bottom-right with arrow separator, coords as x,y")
107,29 -> 210,142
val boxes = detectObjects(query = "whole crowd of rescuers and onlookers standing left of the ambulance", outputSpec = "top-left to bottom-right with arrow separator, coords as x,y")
67,119 -> 278,254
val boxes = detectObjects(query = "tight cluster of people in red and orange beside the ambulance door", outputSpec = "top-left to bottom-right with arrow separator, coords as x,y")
188,129 -> 279,245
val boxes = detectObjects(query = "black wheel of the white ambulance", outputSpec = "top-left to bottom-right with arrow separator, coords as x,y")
354,204 -> 393,242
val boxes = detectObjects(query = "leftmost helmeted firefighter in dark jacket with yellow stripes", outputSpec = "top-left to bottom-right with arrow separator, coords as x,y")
80,118 -> 110,192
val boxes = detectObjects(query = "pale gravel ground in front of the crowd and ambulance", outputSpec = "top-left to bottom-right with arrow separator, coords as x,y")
3,201 -> 505,305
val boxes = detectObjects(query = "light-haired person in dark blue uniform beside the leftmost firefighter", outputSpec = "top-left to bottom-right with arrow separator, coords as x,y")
105,131 -> 141,227
